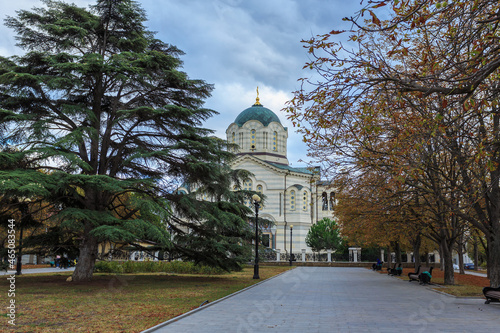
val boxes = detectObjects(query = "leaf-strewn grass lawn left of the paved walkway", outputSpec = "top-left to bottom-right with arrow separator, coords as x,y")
0,266 -> 290,332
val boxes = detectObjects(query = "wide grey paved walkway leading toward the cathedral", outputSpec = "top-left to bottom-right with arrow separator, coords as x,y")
145,267 -> 500,333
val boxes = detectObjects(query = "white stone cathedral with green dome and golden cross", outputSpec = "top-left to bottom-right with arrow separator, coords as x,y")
226,92 -> 335,254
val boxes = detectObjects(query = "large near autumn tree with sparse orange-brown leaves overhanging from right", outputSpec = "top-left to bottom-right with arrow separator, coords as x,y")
289,0 -> 500,286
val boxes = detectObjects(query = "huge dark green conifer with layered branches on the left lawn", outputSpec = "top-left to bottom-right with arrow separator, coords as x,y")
0,0 -> 250,281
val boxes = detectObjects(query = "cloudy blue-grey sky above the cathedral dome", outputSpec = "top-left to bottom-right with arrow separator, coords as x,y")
0,0 -> 366,166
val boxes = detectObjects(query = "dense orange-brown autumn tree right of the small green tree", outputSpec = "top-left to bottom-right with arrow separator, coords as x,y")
335,169 -> 435,266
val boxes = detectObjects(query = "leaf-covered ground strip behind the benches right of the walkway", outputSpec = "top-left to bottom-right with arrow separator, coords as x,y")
381,268 -> 490,297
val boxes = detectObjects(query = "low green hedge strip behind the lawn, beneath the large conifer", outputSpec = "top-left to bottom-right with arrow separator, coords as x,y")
94,261 -> 225,275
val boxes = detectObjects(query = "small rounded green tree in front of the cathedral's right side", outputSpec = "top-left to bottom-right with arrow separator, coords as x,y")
306,218 -> 343,252
